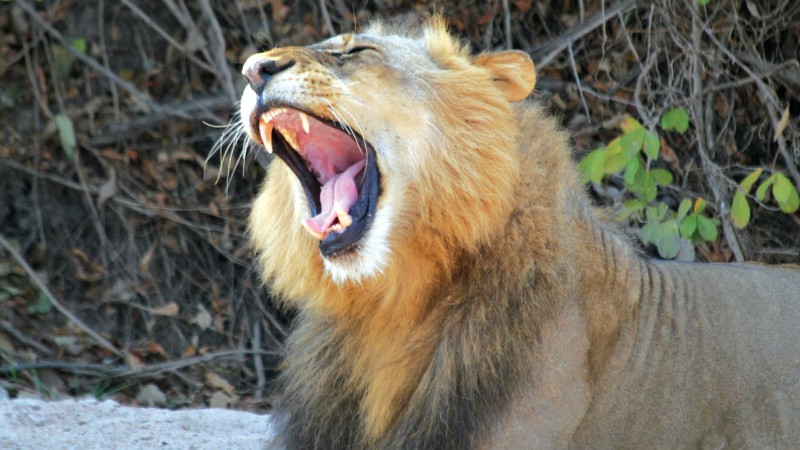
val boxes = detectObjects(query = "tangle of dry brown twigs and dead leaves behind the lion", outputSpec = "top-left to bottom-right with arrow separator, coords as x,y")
0,0 -> 800,408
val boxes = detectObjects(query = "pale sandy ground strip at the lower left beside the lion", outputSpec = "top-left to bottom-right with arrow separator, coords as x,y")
0,398 -> 269,450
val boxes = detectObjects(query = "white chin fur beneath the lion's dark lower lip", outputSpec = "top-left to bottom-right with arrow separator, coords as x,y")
323,205 -> 394,285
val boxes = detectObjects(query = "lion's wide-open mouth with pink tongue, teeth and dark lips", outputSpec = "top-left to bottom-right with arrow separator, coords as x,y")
253,108 -> 380,257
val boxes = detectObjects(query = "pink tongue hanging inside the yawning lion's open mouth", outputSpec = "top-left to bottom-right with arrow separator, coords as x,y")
303,160 -> 366,240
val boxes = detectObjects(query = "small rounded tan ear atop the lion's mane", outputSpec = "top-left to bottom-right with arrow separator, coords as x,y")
473,50 -> 536,102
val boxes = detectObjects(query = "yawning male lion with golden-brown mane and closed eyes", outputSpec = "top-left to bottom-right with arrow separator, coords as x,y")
234,19 -> 800,449
